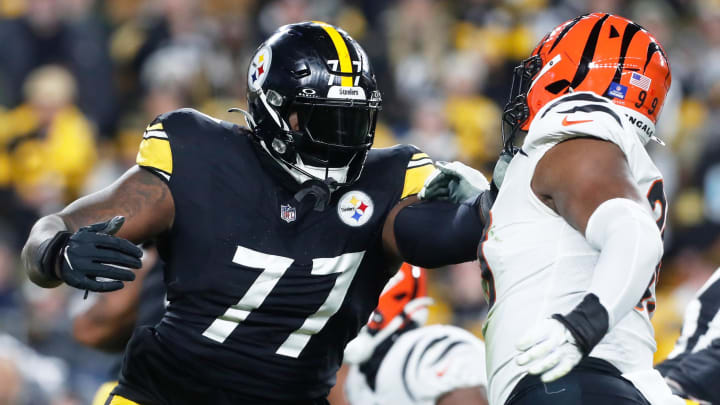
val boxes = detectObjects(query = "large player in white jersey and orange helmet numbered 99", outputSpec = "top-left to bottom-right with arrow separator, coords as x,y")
456,13 -> 682,405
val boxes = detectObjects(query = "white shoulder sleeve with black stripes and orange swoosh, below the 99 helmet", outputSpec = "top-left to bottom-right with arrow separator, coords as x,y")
522,92 -> 639,154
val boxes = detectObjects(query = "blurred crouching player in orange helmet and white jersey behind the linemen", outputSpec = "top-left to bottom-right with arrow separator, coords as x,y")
340,264 -> 487,405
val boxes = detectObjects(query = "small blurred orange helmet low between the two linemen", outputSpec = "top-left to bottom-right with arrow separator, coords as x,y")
367,263 -> 431,333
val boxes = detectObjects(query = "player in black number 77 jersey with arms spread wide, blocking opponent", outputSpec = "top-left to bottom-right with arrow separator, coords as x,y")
23,22 -> 490,405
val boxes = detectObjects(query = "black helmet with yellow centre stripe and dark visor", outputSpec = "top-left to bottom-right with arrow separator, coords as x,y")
240,22 -> 382,188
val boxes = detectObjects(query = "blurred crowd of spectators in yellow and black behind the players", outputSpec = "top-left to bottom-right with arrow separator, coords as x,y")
0,0 -> 720,405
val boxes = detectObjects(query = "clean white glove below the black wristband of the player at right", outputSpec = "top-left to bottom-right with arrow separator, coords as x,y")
515,318 -> 583,383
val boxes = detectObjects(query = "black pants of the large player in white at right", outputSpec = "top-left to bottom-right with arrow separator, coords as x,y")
505,358 -> 650,405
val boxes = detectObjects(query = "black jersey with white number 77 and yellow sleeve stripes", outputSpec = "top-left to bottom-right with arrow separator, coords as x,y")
116,109 -> 433,404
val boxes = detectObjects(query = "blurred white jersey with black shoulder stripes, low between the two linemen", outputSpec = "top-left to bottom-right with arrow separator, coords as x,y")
345,325 -> 487,405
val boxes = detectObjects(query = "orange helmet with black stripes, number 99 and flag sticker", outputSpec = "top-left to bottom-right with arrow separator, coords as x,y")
503,13 -> 671,150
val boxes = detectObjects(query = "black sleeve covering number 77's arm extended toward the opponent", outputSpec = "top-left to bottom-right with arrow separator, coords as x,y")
395,197 -> 484,268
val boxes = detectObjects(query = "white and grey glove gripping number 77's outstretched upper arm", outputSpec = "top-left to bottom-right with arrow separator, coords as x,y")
418,162 -> 490,204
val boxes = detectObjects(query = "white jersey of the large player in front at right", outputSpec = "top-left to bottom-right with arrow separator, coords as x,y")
481,92 -> 665,405
